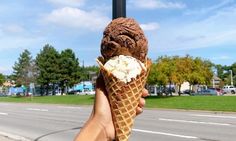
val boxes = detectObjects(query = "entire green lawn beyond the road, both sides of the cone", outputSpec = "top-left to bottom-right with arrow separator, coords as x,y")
0,95 -> 236,112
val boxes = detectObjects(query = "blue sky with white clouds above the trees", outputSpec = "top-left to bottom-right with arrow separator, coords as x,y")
0,0 -> 236,74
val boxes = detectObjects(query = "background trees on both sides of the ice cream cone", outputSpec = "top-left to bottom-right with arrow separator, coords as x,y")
0,44 -> 236,94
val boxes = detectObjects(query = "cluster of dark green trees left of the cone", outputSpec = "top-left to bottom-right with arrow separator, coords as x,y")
7,44 -> 99,95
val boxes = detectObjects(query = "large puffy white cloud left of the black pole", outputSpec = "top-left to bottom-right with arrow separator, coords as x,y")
44,7 -> 110,31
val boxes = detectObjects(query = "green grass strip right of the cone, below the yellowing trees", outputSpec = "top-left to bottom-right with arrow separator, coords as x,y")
146,96 -> 236,112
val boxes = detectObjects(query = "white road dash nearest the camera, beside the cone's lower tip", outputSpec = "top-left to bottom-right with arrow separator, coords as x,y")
132,129 -> 198,139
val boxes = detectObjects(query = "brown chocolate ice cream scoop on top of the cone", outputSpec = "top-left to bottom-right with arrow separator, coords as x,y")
101,17 -> 148,62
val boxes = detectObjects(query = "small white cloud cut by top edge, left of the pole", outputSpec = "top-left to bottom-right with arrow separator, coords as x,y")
47,0 -> 86,7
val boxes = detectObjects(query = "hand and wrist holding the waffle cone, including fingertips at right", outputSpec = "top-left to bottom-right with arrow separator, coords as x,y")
74,76 -> 148,141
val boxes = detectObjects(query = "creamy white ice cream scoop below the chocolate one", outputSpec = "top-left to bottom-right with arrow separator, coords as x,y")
104,55 -> 146,83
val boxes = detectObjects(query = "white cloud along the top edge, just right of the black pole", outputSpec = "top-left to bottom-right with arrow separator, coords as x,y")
129,0 -> 186,9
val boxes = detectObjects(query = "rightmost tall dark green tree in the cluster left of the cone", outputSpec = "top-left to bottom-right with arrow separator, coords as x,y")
59,49 -> 80,93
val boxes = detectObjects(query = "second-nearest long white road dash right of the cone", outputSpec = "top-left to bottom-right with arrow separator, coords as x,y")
159,118 -> 231,126
